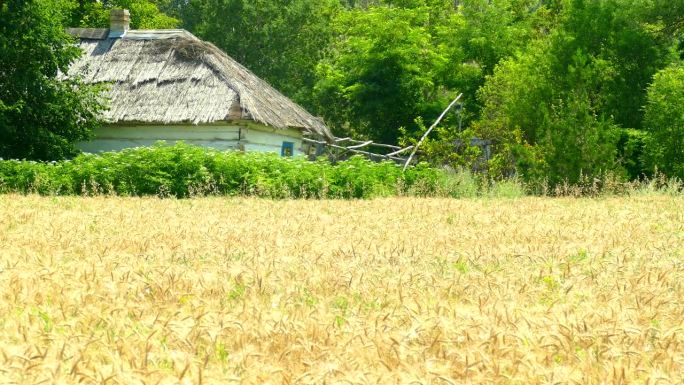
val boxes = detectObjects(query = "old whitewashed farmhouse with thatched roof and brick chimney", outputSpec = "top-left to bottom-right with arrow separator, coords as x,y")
69,10 -> 332,156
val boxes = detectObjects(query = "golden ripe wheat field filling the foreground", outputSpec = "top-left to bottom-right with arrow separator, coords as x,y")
0,195 -> 684,384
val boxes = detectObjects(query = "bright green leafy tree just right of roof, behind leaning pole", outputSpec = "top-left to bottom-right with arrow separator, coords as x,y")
316,0 -> 551,147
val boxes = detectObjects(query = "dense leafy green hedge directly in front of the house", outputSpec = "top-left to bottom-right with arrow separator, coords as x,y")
0,143 -> 459,199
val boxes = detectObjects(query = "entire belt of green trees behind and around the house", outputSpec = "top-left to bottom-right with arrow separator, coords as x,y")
0,0 -> 684,188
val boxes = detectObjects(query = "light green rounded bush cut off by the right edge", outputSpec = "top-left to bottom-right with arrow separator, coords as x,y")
644,63 -> 684,180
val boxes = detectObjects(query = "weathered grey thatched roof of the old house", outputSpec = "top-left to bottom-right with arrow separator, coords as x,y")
69,28 -> 332,138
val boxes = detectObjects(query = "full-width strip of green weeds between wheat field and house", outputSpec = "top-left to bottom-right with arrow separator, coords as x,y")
0,142 -> 682,199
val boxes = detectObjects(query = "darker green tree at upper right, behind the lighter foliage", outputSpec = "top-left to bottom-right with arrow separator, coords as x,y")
552,0 -> 670,129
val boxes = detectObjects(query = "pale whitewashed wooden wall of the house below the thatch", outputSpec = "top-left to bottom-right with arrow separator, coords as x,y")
77,124 -> 303,155
